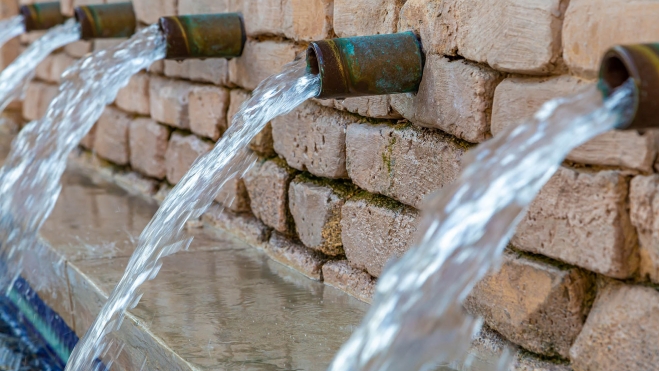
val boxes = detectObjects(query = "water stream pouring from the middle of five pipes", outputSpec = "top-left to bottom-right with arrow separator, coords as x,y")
0,24 -> 165,300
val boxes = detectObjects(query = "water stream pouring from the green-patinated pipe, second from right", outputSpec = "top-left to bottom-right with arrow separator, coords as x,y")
66,60 -> 320,371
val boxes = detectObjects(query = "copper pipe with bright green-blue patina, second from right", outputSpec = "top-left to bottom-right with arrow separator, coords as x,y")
307,32 -> 424,98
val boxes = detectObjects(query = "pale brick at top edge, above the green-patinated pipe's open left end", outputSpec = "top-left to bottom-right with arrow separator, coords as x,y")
282,0 -> 334,41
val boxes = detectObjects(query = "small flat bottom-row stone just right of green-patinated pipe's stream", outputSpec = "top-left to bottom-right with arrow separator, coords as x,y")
202,204 -> 271,246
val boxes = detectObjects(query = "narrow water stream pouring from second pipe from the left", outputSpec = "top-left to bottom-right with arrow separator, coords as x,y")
0,17 -> 80,112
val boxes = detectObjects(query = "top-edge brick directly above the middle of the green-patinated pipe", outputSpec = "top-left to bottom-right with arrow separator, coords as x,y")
334,0 -> 405,37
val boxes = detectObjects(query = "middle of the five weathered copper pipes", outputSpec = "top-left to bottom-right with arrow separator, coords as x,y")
159,13 -> 246,60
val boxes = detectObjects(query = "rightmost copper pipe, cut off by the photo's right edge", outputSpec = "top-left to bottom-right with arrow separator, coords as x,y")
600,44 -> 659,129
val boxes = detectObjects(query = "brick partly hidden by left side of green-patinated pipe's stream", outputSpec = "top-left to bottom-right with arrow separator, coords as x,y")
165,132 -> 213,184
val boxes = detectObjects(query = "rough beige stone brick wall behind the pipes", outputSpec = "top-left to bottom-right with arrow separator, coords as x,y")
6,0 -> 659,371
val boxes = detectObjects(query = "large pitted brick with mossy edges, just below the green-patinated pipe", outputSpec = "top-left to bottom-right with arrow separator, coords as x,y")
346,124 -> 469,208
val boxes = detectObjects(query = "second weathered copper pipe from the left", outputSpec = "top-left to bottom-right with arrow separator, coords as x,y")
75,3 -> 137,40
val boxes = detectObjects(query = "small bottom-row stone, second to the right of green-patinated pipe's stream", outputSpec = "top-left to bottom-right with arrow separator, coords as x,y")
265,232 -> 327,281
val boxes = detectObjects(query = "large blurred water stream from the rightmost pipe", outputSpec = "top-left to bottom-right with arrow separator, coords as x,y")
329,81 -> 635,371
